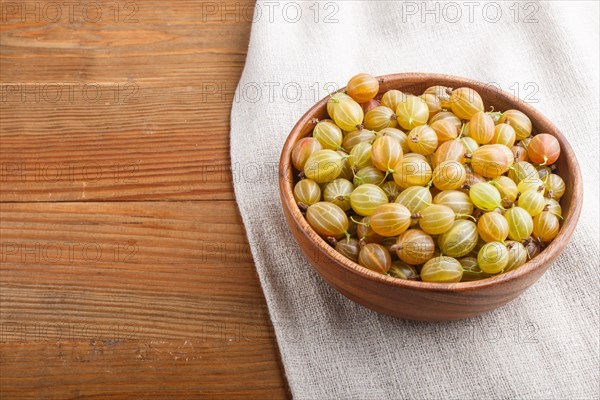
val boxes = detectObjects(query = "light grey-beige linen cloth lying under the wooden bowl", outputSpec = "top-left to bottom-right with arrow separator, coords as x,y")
231,1 -> 600,399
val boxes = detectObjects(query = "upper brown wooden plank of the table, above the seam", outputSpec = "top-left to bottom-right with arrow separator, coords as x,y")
0,1 -> 253,201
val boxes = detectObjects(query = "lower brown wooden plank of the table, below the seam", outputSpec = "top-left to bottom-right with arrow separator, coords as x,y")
0,201 -> 286,398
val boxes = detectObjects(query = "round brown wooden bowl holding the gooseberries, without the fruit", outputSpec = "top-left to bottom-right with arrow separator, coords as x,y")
279,73 -> 583,321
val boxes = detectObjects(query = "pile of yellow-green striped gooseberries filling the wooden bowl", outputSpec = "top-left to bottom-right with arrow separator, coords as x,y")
291,74 -> 565,283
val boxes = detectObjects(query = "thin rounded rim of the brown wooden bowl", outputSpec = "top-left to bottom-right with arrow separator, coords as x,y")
278,72 -> 583,292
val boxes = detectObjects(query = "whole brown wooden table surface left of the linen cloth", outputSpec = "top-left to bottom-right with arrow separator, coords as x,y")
0,0 -> 288,399
